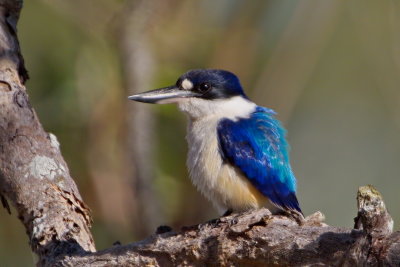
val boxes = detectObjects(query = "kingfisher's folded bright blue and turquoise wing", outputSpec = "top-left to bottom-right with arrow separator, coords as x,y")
217,107 -> 301,213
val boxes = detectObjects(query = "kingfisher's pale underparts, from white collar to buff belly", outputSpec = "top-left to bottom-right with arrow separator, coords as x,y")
179,98 -> 274,216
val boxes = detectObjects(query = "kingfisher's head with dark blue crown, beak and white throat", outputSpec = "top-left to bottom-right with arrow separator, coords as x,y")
129,69 -> 251,118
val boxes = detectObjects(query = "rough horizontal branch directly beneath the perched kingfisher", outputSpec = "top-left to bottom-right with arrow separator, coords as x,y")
53,209 -> 400,266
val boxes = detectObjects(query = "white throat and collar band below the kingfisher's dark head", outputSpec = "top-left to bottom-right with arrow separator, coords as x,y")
178,96 -> 257,120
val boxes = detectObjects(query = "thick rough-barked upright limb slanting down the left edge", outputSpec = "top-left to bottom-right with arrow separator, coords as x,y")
0,0 -> 95,264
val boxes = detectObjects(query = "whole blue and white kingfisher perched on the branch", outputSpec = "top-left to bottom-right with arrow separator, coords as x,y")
128,69 -> 303,217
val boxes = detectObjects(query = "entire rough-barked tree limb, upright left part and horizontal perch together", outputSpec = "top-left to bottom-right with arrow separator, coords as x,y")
0,0 -> 400,266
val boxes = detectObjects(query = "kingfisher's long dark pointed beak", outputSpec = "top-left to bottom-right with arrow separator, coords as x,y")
128,86 -> 200,104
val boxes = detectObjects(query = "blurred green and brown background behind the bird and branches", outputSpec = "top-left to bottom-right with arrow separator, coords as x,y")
0,0 -> 400,266
